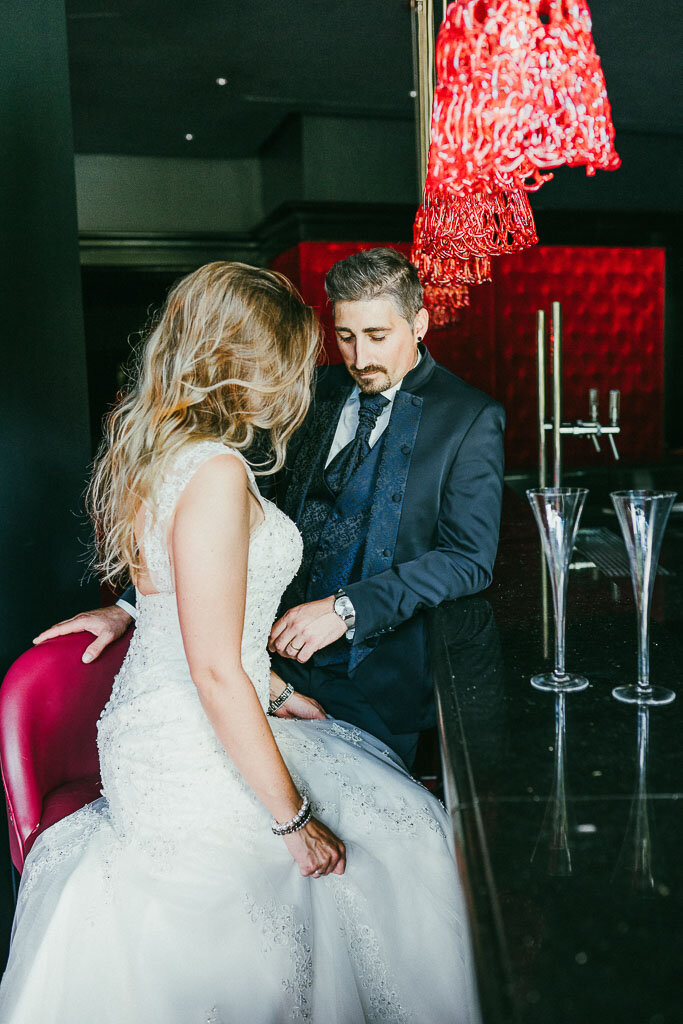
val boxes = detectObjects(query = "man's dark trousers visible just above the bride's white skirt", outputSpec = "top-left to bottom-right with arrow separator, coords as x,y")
272,654 -> 420,769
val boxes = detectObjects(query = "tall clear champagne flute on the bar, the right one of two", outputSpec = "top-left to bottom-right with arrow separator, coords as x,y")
609,490 -> 676,705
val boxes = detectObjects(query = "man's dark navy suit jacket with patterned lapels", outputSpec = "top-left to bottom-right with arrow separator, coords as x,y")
278,345 -> 505,732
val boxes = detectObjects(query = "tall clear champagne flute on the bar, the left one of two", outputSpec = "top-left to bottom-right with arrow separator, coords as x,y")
526,487 -> 588,692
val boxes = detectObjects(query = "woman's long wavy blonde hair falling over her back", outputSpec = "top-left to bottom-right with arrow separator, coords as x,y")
87,262 -> 322,583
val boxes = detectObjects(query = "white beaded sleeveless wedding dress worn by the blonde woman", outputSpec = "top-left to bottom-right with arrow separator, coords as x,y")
0,441 -> 478,1024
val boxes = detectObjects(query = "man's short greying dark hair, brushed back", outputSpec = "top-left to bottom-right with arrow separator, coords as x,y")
325,249 -> 424,324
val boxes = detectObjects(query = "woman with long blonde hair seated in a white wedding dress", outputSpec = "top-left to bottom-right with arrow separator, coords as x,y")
0,263 -> 476,1024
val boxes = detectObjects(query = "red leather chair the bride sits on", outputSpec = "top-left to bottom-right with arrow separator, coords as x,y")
0,630 -> 132,871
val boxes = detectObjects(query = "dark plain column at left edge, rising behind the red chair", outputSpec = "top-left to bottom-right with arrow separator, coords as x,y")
0,0 -> 97,676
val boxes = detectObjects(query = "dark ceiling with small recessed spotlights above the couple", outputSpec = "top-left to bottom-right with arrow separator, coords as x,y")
67,0 -> 683,158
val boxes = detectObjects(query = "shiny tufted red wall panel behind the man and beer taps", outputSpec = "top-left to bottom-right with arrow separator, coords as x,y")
272,242 -> 665,469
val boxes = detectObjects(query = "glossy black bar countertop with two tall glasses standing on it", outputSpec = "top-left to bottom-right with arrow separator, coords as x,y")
431,468 -> 683,1024
